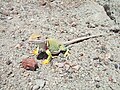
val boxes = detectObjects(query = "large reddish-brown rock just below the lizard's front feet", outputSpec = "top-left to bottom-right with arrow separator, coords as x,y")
22,58 -> 38,71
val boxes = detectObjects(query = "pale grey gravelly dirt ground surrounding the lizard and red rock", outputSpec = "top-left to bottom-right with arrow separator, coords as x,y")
0,0 -> 120,90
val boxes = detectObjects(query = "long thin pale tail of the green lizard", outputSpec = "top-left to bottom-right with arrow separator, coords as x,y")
63,34 -> 104,46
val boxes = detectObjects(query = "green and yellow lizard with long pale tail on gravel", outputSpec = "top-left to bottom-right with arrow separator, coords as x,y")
29,34 -> 108,64
